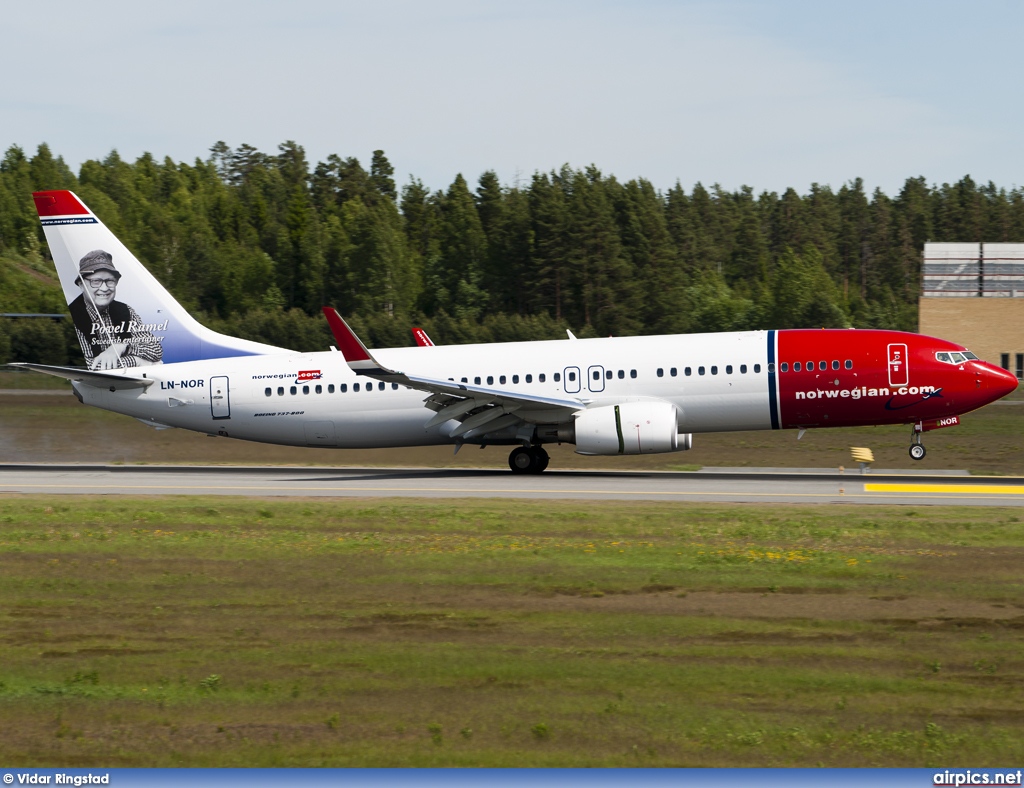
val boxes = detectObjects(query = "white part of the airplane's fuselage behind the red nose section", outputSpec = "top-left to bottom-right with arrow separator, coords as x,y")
76,332 -> 771,448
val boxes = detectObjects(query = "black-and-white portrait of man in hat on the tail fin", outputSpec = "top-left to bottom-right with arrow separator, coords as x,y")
69,249 -> 163,369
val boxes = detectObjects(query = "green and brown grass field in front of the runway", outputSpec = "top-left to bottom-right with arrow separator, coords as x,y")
0,495 -> 1024,767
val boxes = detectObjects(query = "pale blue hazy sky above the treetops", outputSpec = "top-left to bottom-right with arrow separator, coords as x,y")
0,0 -> 1024,193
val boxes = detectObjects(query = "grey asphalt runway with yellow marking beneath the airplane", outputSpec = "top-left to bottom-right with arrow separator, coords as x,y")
0,465 -> 1024,507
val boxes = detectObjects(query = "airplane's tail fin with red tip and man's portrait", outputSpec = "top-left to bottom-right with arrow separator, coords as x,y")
32,191 -> 289,369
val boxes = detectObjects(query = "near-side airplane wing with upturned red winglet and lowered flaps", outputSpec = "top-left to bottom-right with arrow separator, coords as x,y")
324,306 -> 587,438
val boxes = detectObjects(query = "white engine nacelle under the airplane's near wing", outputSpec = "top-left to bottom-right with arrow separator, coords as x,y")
573,401 -> 693,454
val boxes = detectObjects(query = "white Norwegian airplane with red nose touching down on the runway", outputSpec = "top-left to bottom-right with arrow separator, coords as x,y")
12,190 -> 1018,474
